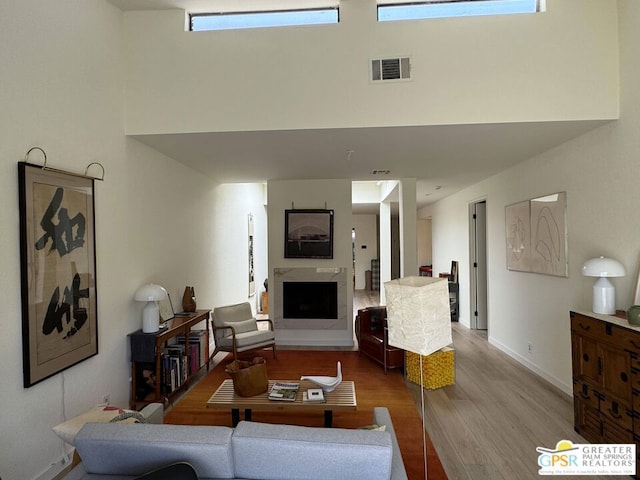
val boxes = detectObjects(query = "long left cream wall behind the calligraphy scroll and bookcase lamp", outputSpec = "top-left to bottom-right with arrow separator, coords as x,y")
0,0 -> 266,480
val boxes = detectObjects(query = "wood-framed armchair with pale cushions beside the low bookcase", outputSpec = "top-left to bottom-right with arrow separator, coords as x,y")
213,302 -> 276,359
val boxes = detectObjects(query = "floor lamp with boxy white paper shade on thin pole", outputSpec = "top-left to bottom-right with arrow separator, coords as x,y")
384,277 -> 453,479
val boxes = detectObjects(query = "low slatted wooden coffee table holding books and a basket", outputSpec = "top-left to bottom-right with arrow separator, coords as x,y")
207,379 -> 358,427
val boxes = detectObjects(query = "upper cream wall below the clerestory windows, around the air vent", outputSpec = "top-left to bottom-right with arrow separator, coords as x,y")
125,0 -> 618,134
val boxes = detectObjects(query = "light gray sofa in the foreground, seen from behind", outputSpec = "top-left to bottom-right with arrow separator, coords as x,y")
65,407 -> 407,480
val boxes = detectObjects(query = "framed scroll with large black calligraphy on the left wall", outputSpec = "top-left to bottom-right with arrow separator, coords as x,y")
18,162 -> 98,387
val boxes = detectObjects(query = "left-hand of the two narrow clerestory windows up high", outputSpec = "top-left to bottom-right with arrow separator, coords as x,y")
190,5 -> 339,32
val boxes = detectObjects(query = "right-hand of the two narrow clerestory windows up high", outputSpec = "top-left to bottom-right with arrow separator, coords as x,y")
378,0 -> 544,22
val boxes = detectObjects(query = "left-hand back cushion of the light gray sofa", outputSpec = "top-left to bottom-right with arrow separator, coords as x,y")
75,423 -> 234,478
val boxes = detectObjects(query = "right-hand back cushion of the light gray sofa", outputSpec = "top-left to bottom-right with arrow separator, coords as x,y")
231,421 -> 393,480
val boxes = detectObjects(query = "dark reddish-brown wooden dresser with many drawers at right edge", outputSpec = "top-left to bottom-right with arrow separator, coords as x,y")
570,311 -> 640,450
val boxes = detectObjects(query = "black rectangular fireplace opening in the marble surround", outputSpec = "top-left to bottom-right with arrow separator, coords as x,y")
282,282 -> 338,319
